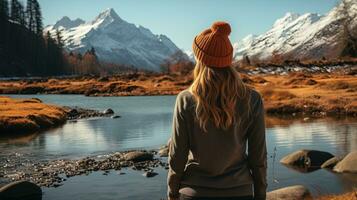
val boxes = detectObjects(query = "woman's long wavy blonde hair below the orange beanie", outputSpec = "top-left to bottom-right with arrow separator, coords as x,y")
189,61 -> 249,132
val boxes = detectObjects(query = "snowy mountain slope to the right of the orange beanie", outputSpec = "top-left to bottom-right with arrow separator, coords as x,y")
234,0 -> 357,60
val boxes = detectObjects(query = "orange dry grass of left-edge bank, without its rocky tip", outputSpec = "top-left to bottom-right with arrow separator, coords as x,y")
0,96 -> 66,134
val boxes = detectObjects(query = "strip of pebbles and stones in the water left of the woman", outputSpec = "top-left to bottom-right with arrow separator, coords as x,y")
0,150 -> 168,187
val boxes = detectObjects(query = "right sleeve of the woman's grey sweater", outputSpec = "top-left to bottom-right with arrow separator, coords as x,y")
248,93 -> 267,200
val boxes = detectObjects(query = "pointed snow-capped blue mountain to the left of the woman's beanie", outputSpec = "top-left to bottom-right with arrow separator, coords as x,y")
44,8 -> 181,71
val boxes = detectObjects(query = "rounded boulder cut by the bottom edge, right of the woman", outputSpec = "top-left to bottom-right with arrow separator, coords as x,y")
267,185 -> 312,200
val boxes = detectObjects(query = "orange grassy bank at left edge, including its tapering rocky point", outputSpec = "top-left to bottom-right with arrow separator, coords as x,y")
0,96 -> 119,136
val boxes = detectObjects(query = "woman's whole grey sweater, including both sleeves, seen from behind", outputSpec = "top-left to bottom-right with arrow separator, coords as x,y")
167,90 -> 267,200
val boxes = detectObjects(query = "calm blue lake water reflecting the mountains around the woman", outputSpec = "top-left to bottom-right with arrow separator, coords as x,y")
0,95 -> 357,200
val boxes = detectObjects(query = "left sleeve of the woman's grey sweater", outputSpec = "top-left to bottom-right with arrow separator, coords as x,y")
167,95 -> 189,198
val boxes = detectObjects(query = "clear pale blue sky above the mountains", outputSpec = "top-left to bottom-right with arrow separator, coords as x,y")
39,0 -> 339,50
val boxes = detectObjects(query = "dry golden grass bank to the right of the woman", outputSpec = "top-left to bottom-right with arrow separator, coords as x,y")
252,74 -> 357,116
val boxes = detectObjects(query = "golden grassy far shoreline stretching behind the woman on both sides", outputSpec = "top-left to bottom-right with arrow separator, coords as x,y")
0,72 -> 357,117
